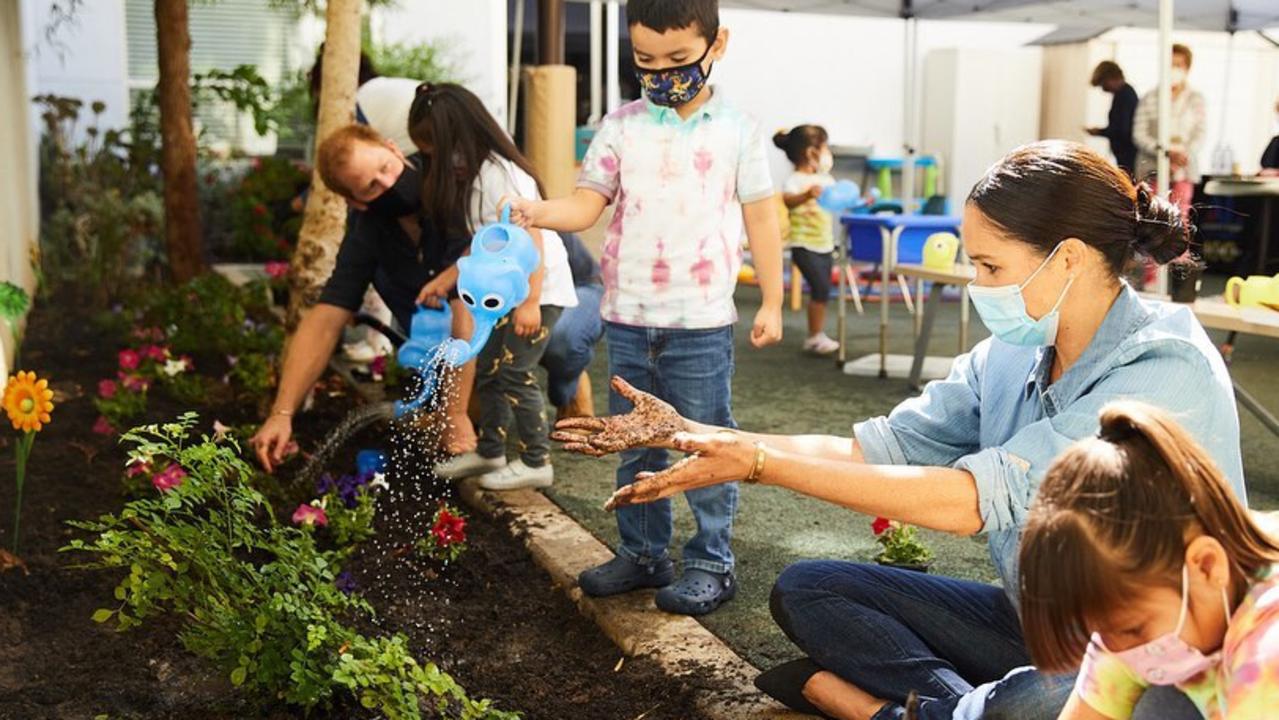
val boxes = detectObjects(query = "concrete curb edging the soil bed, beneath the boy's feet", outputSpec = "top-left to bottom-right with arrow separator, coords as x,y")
459,480 -> 812,720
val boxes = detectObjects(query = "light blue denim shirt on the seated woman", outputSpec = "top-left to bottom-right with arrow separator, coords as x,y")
853,284 -> 1247,606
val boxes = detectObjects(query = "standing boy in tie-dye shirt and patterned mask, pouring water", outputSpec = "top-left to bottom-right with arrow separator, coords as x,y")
510,0 -> 781,615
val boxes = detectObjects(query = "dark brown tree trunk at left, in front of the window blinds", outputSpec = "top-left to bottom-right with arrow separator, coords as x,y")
155,0 -> 205,283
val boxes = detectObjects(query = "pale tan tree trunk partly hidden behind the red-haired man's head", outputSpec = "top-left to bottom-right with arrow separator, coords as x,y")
286,0 -> 363,334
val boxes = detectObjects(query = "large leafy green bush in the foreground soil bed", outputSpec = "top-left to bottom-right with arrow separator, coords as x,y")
63,413 -> 517,720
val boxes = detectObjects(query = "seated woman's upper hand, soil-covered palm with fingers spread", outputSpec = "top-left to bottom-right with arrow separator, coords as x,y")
551,376 -> 688,458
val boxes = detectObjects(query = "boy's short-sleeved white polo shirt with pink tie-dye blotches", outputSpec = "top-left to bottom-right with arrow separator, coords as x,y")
577,88 -> 774,330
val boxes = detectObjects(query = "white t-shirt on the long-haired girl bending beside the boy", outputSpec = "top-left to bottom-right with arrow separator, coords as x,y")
471,156 -> 577,307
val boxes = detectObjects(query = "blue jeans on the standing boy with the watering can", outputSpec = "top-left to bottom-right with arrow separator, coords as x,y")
605,322 -> 737,573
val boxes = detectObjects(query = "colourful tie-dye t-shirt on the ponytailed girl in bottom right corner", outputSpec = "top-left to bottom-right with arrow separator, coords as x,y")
1074,568 -> 1279,720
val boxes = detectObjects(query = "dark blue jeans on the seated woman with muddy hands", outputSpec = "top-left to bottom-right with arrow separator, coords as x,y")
769,560 -> 1200,720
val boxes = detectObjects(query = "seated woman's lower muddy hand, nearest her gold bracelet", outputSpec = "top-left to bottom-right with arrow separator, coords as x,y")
604,431 -> 755,510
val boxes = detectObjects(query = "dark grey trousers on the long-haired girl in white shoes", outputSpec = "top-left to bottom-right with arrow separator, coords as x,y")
476,306 -> 561,468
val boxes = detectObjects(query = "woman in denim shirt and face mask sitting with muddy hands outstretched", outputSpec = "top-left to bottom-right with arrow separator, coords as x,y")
559,142 -> 1244,720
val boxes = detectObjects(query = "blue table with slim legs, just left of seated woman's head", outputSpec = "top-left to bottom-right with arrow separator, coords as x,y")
839,215 -> 962,377
